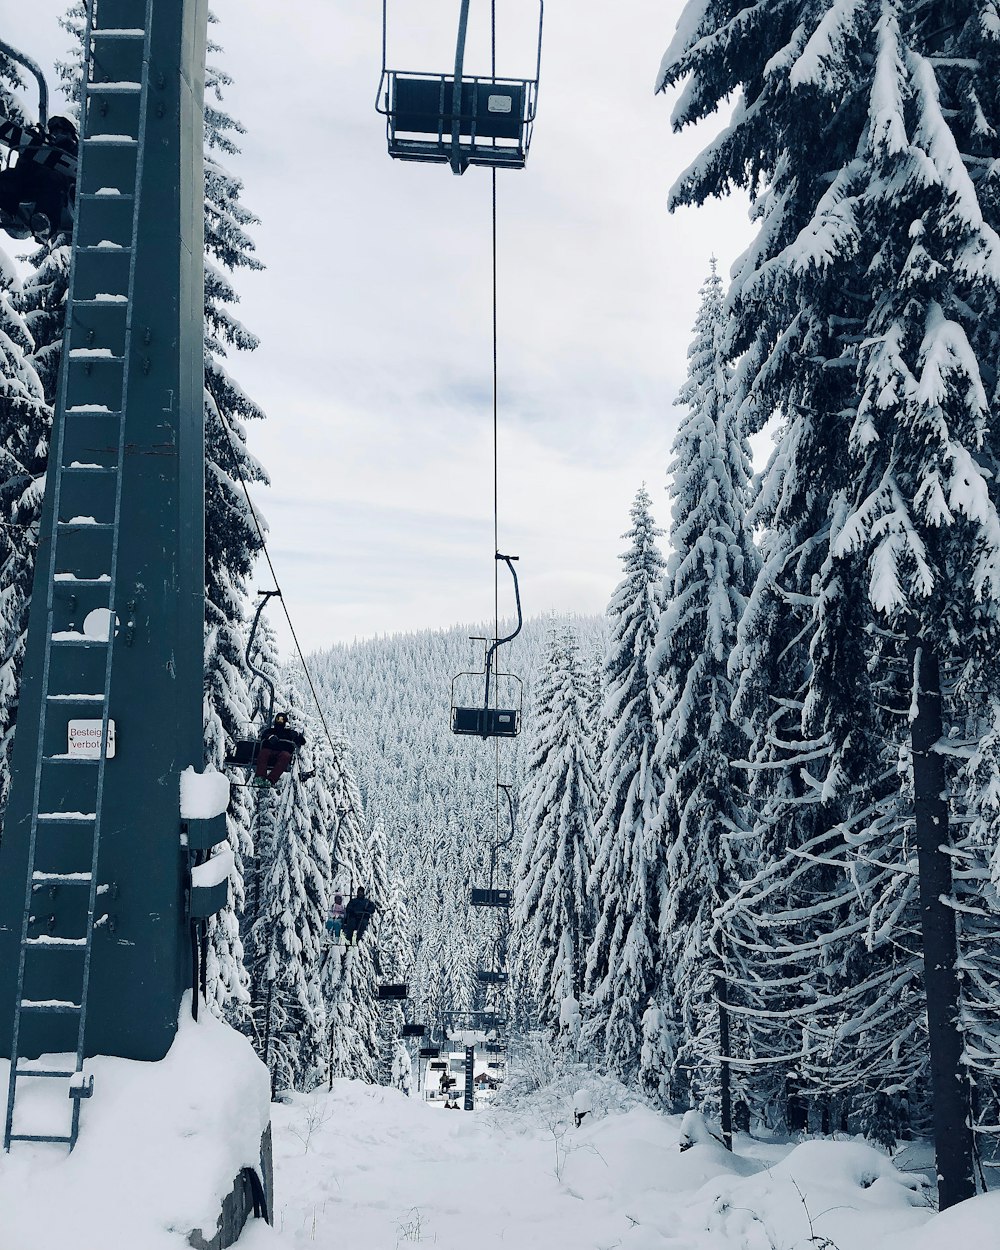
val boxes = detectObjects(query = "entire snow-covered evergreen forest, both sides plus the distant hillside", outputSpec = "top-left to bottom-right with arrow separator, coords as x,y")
0,0 -> 1000,1205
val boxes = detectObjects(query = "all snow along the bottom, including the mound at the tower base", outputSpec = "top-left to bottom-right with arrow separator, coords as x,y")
0,1045 -> 1000,1250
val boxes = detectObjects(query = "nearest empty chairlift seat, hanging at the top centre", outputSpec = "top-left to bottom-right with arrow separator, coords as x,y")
376,0 -> 544,174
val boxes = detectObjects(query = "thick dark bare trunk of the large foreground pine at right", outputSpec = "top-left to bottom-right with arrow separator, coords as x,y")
910,636 -> 976,1211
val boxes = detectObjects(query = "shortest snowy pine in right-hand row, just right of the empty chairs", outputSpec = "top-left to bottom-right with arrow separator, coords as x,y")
515,626 -> 596,1045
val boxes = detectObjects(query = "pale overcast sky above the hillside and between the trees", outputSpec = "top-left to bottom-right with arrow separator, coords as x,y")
3,0 -> 749,649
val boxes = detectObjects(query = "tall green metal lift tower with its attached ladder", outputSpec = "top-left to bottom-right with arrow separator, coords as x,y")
0,0 -> 215,1146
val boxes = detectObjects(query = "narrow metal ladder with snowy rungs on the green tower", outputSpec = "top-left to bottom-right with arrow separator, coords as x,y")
4,0 -> 153,1150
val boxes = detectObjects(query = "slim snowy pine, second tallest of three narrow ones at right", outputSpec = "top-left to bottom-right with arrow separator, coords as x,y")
585,486 -> 664,1081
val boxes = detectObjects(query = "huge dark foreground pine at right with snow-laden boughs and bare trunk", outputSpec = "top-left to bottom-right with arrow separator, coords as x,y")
663,0 -> 1000,1205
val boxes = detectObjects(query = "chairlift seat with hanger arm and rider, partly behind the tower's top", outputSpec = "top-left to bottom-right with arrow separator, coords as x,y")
0,40 -> 80,244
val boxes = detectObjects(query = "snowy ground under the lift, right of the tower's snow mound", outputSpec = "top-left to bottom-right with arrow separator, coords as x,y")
240,1081 -> 1000,1250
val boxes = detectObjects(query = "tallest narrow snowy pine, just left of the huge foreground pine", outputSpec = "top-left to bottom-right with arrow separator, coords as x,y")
644,263 -> 758,1134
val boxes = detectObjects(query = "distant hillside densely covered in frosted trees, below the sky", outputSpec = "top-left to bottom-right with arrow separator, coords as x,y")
310,618 -> 605,1020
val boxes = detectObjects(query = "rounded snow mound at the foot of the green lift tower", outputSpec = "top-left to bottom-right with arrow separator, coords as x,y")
0,995 -> 270,1250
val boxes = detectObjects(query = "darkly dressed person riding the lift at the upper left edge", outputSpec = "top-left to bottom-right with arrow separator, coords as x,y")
0,118 -> 80,243
